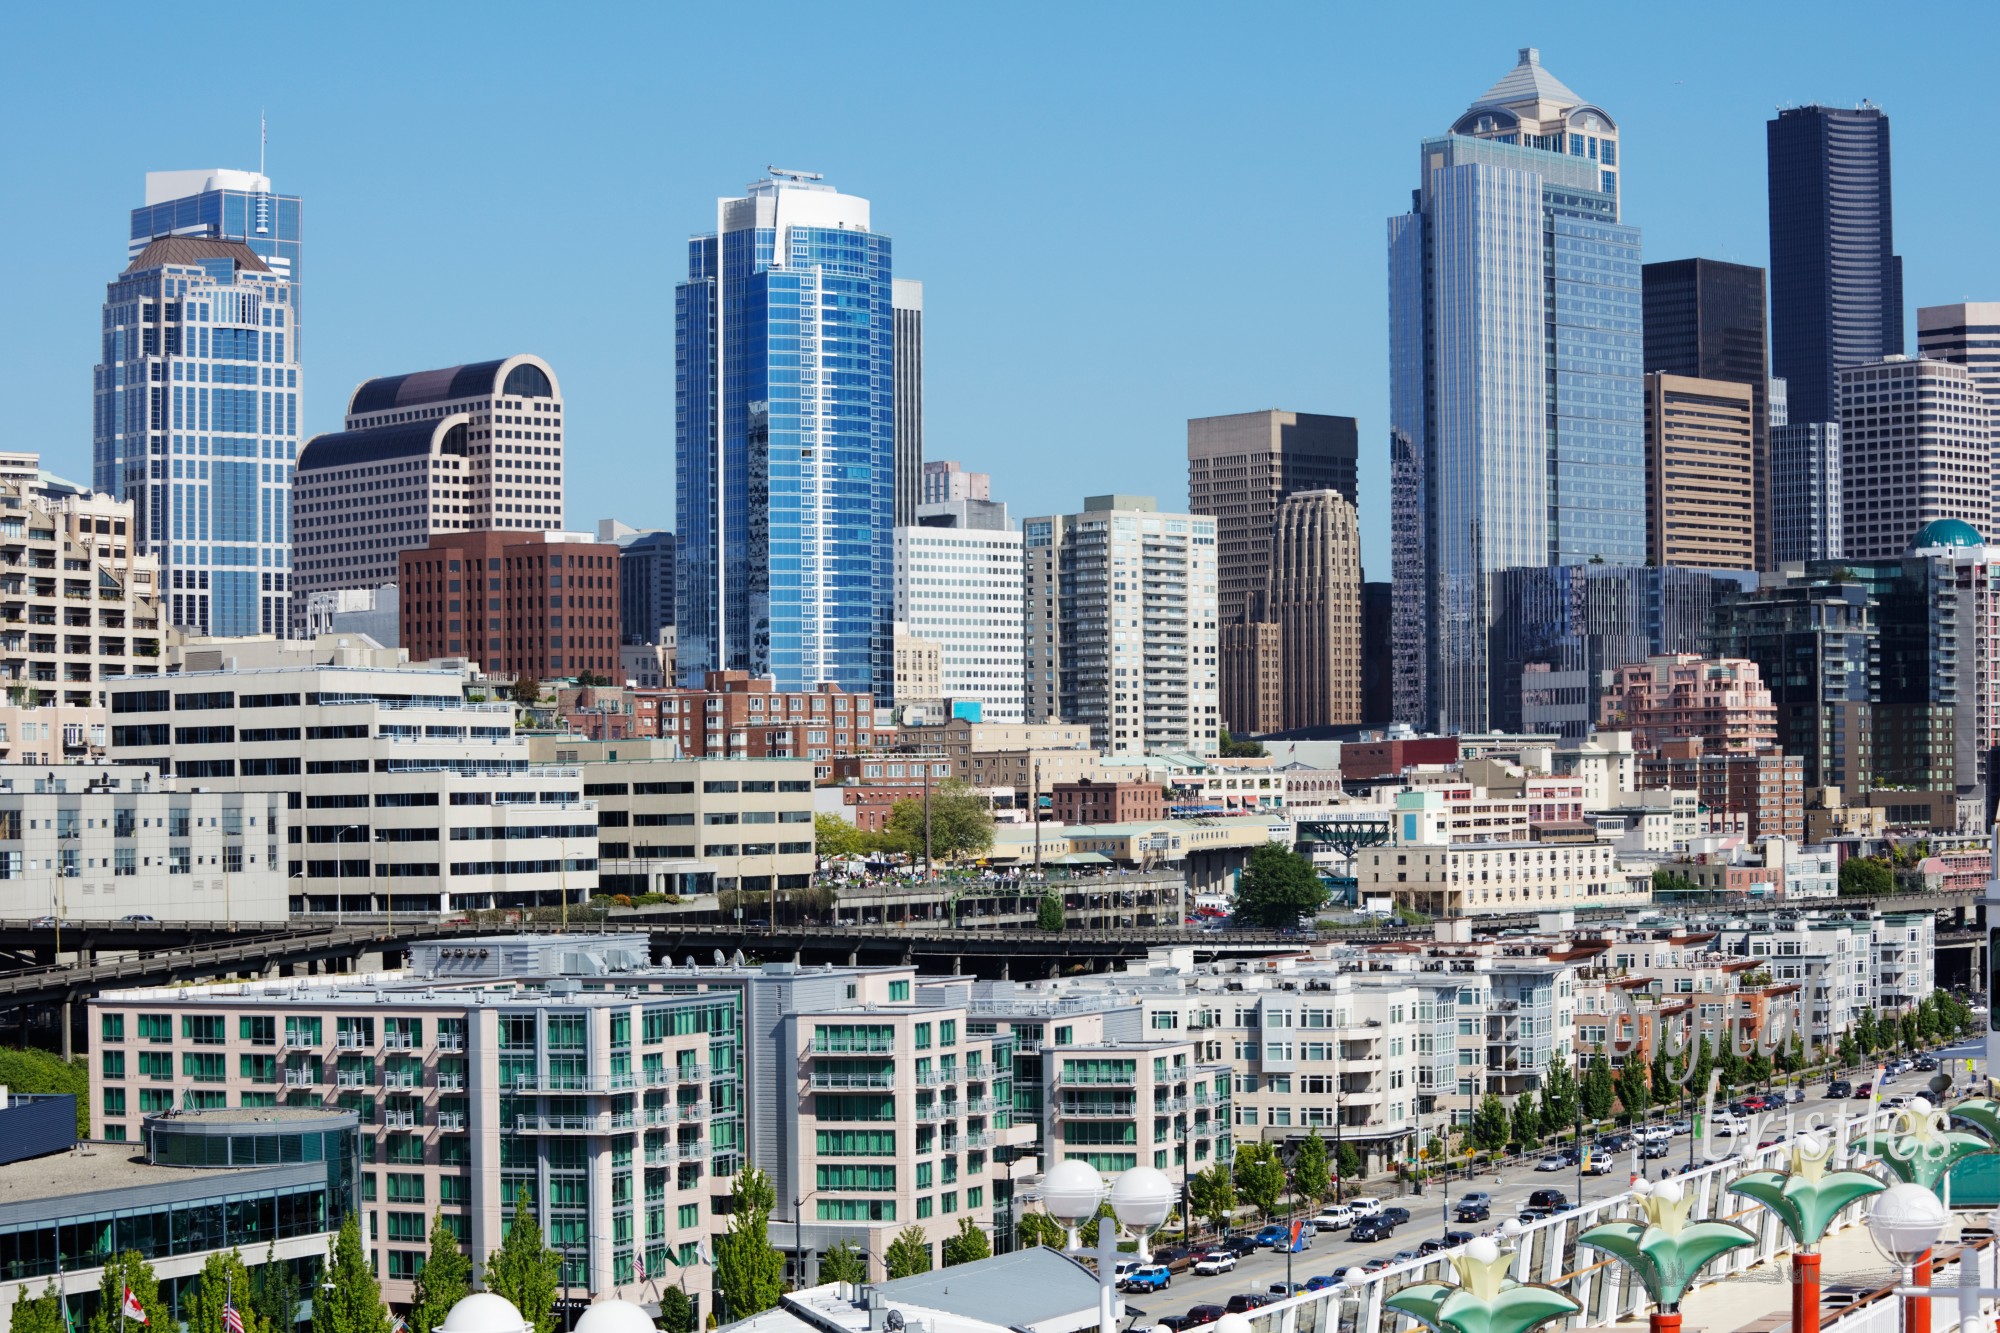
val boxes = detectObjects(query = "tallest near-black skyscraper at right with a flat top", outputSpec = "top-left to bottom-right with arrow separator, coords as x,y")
1764,102 -> 1902,422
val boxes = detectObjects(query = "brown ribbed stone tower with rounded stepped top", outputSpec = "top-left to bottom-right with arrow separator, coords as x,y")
1266,490 -> 1362,731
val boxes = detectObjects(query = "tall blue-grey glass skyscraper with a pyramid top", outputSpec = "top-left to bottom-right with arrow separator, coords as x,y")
1388,48 -> 1646,733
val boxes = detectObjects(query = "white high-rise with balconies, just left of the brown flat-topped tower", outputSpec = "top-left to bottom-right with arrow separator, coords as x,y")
1022,494 -> 1222,755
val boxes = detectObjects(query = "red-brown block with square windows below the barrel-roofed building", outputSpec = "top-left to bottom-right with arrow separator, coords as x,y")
396,528 -> 620,679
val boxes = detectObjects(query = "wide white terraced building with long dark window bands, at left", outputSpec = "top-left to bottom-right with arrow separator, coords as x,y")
108,636 -> 598,913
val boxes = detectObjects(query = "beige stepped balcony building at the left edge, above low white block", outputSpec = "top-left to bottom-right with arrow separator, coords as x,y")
0,454 -> 162,700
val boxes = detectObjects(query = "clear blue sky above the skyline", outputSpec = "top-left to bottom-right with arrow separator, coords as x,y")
0,0 -> 2000,578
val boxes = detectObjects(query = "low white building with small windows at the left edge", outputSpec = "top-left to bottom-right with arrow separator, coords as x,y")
0,756 -> 286,925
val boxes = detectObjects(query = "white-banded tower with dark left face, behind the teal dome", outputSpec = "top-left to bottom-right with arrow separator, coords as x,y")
1840,356 -> 1994,560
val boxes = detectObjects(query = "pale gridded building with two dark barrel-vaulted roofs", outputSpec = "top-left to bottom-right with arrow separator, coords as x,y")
292,356 -> 564,626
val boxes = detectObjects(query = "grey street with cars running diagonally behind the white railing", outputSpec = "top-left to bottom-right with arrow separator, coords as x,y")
1124,1041 -> 1984,1327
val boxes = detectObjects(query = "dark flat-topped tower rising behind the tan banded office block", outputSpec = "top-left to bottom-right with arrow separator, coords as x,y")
1644,258 -> 1774,568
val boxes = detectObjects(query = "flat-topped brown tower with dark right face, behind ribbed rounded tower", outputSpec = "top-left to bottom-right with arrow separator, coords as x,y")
1188,410 -> 1358,735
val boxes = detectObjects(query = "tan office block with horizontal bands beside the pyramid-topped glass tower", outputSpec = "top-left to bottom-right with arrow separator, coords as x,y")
1646,372 -> 1760,568
